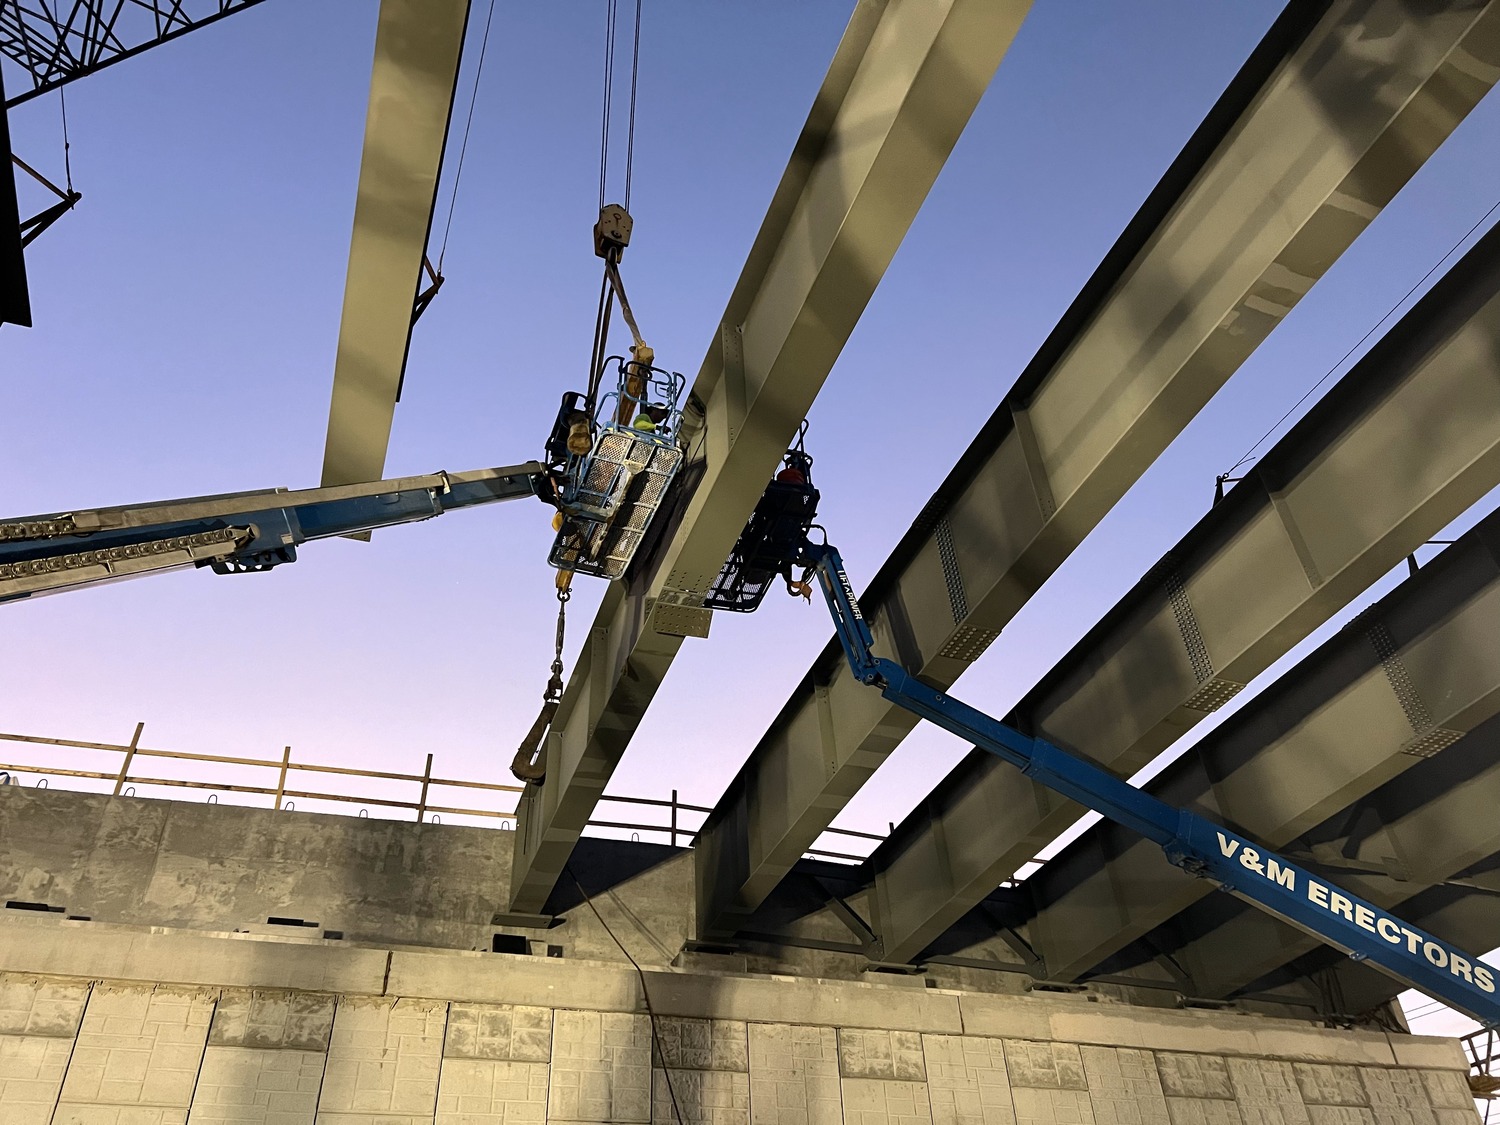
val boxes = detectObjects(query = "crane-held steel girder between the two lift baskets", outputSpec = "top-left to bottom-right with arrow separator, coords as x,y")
512,0 -> 1031,912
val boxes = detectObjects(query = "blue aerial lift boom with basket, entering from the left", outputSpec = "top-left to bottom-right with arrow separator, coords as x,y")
0,344 -> 684,602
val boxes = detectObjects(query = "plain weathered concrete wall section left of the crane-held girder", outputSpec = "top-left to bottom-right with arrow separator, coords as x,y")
0,786 -> 513,950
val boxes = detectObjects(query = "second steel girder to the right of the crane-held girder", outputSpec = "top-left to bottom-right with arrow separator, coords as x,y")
872,211 -> 1500,974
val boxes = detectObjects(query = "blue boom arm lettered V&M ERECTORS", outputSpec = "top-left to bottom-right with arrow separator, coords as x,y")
797,543 -> 1500,1028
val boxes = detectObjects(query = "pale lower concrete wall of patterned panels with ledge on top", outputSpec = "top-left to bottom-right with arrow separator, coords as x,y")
0,972 -> 1476,1125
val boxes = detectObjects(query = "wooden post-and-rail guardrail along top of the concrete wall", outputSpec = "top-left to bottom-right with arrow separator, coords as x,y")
0,723 -> 885,863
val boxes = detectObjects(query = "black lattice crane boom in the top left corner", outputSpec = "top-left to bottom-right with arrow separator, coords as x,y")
0,0 -> 261,105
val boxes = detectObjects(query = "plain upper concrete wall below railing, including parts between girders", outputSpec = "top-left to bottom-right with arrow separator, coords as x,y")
0,786 -> 1025,992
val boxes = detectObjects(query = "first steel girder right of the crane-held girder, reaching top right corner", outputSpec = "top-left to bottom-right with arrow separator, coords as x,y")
696,0 -> 1500,960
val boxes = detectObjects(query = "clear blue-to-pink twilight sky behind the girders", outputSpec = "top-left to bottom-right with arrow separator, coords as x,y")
0,0 -> 1500,1038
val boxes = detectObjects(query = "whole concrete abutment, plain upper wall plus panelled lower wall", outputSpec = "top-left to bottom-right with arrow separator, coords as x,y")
0,789 -> 1475,1125
